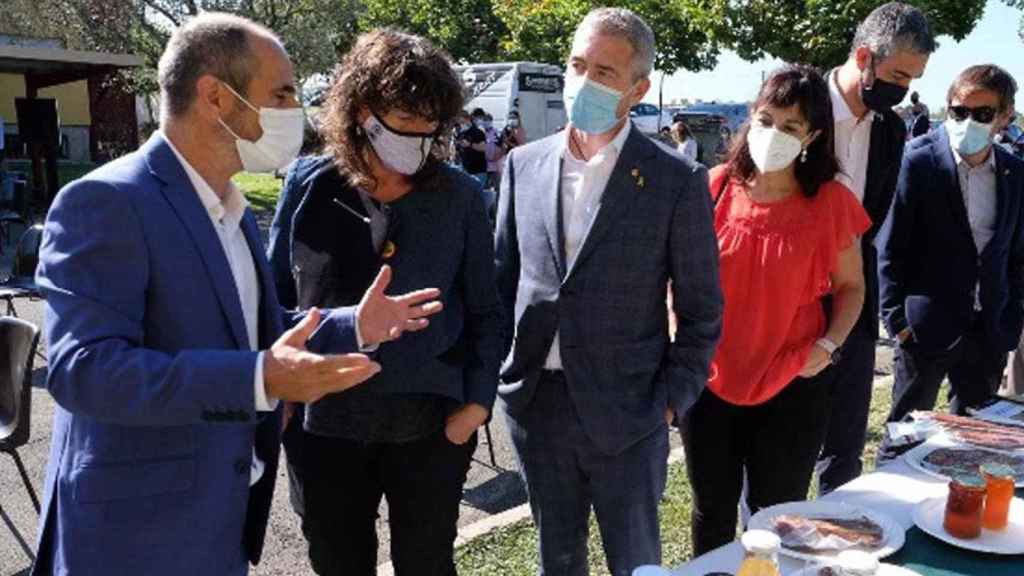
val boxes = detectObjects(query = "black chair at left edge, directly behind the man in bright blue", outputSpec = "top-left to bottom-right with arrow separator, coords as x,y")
0,316 -> 39,513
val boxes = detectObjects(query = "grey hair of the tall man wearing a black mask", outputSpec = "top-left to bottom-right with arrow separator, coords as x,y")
851,2 -> 936,59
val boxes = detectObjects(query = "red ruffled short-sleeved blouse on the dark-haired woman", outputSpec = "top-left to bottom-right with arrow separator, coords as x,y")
708,165 -> 871,406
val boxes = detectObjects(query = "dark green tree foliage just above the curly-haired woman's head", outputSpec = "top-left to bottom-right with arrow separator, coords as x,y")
359,0 -> 507,63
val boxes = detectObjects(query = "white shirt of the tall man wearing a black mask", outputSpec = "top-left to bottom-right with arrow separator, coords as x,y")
828,69 -> 874,203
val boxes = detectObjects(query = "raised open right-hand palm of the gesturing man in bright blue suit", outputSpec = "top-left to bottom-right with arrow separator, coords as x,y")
356,265 -> 443,346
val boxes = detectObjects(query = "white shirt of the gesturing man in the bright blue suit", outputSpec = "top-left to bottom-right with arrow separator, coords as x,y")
164,136 -> 278,486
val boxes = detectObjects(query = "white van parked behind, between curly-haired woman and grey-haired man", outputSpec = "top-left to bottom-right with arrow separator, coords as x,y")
455,61 -> 567,140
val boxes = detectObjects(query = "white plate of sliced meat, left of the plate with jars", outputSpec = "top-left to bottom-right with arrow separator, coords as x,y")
748,500 -> 906,563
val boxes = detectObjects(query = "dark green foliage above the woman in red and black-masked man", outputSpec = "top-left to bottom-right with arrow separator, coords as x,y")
724,0 -> 987,69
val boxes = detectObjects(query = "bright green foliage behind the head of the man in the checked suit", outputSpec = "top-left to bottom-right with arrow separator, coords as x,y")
495,0 -> 726,73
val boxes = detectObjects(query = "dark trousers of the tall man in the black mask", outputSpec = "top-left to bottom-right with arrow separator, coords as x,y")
817,323 -> 877,496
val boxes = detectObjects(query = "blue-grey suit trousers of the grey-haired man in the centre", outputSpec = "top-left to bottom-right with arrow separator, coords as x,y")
508,373 -> 669,576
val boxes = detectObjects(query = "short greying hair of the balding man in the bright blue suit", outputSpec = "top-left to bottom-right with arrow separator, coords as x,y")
157,12 -> 280,118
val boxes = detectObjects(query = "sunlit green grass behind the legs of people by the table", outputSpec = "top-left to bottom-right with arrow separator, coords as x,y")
456,379 -> 948,576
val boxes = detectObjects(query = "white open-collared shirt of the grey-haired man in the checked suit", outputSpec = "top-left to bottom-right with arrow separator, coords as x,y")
544,121 -> 632,370
